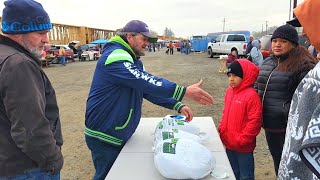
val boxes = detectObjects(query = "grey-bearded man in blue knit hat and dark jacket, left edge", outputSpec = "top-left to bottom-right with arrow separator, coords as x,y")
0,0 -> 63,179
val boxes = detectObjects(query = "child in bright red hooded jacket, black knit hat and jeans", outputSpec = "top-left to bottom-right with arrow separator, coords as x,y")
218,59 -> 262,180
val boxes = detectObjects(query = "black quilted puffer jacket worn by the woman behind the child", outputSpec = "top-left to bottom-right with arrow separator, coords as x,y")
255,56 -> 315,132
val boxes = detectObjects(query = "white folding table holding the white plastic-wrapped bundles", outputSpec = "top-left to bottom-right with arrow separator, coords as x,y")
105,117 -> 235,180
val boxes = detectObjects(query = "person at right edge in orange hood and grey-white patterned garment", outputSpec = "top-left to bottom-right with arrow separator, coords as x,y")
278,0 -> 320,180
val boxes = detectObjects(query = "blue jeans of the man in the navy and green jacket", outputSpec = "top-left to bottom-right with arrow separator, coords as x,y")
85,135 -> 123,180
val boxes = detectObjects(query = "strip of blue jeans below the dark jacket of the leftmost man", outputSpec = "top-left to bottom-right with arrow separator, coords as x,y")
0,169 -> 60,180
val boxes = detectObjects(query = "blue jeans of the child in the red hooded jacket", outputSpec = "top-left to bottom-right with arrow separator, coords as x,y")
226,149 -> 254,180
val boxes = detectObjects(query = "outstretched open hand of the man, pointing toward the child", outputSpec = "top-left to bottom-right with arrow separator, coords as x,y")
184,79 -> 213,105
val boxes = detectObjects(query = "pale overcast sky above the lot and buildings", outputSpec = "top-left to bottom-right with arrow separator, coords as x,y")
0,0 -> 303,38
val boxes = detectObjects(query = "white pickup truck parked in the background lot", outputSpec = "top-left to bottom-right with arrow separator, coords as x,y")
207,34 -> 247,58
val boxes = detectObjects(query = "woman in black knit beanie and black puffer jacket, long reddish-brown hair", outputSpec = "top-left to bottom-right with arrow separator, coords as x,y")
255,24 -> 316,174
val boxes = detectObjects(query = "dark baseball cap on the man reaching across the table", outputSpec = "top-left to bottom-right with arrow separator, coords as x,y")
122,20 -> 158,43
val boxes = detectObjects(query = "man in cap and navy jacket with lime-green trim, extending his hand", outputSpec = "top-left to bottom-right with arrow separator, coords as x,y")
85,20 -> 213,180
